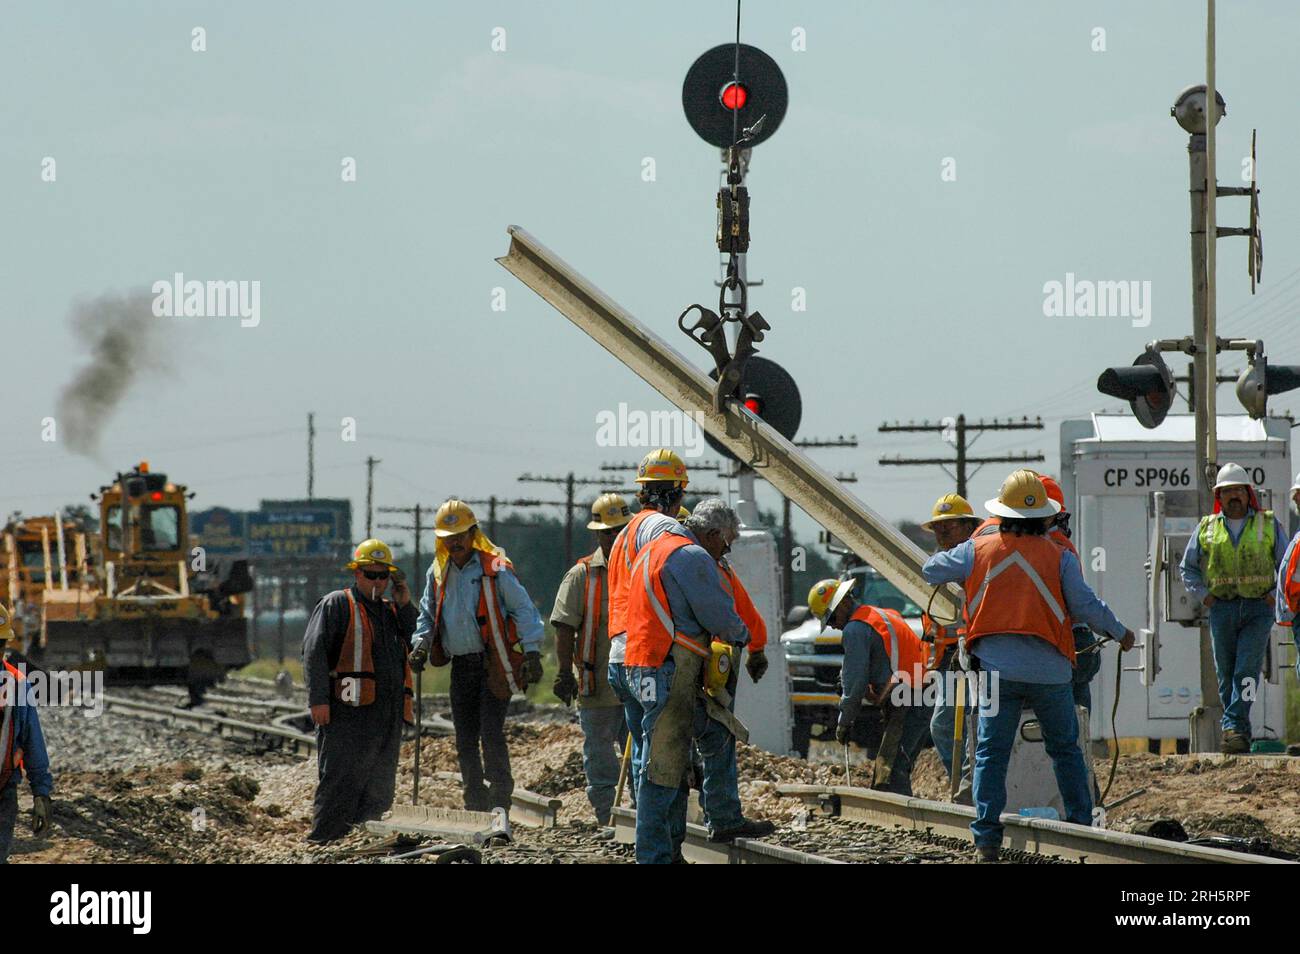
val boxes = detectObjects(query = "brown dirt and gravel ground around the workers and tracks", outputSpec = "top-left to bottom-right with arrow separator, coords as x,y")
10,714 -> 1300,863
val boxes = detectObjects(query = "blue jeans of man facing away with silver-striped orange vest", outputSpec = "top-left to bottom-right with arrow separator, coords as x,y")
971,678 -> 1092,846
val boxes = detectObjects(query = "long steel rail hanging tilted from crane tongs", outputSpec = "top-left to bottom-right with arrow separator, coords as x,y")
497,225 -> 959,619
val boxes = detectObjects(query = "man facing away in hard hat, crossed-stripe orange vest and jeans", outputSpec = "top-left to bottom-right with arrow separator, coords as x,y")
922,471 -> 1134,862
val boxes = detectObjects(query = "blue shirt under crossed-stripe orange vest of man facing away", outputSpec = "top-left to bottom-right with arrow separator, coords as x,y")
920,539 -> 1126,684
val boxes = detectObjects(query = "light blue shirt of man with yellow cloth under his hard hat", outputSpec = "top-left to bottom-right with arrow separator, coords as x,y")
415,554 -> 545,656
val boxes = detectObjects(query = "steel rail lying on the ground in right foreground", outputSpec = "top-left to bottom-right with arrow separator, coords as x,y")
776,785 -> 1292,864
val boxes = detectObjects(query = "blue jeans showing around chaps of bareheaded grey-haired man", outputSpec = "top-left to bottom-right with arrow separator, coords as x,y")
624,656 -> 689,864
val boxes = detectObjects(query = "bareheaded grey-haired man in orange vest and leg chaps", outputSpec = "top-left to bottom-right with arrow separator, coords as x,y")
624,501 -> 749,864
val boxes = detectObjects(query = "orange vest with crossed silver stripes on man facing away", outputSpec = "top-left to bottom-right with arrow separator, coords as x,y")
966,533 -> 1074,663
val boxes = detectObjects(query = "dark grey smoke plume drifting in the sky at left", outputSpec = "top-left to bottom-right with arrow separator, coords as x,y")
57,291 -> 166,459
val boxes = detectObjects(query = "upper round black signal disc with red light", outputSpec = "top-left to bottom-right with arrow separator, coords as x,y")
681,43 -> 790,149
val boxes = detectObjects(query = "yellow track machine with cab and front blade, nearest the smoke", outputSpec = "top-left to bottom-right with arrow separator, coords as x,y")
39,461 -> 252,701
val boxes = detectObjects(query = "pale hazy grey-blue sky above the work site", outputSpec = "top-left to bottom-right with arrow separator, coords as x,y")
0,0 -> 1300,556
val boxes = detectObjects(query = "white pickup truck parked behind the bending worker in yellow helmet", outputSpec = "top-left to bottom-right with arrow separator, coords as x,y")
781,565 -> 922,758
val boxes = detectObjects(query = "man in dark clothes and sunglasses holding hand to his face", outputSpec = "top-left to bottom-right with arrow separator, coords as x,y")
303,539 -> 416,842
